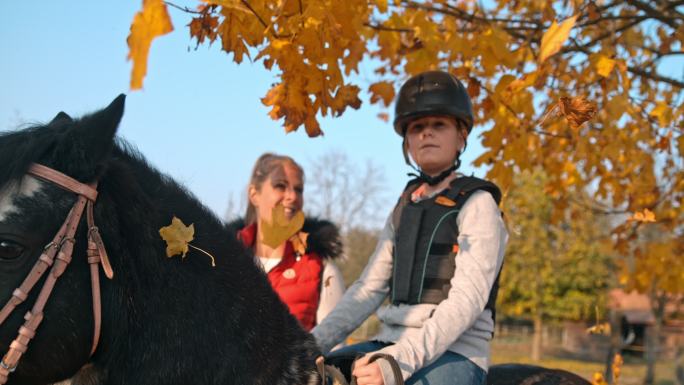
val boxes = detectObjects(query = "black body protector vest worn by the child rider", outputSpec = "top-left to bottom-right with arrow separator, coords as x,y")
390,177 -> 501,318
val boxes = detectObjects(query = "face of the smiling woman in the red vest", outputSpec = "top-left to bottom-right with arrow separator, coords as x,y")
249,162 -> 304,222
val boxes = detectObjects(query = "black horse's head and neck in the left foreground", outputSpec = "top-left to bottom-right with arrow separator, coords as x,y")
0,96 -> 319,385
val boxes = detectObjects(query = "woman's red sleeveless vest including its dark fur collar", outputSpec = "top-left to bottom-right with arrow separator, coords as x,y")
236,219 -> 342,331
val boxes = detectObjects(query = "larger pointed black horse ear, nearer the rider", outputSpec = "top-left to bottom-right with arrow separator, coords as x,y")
48,94 -> 126,182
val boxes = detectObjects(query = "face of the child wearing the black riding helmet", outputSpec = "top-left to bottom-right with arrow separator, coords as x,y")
406,115 -> 464,175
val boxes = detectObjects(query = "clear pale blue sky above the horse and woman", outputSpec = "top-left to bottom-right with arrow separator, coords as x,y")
0,0 -> 492,225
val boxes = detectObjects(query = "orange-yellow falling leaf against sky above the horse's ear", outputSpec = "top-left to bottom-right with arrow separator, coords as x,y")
127,0 -> 173,90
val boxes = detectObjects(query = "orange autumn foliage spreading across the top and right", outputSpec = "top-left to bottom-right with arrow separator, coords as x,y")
129,0 -> 684,306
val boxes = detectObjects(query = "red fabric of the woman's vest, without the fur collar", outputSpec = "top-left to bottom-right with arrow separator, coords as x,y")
238,224 -> 323,331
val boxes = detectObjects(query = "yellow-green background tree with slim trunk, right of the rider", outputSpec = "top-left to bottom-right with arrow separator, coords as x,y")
499,169 -> 613,361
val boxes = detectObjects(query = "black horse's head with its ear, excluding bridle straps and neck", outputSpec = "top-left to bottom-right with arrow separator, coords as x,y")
0,96 -> 124,384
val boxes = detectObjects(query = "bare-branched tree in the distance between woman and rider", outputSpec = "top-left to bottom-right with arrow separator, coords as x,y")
304,151 -> 385,234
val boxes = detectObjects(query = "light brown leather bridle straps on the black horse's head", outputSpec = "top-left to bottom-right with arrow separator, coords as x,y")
0,163 -> 114,385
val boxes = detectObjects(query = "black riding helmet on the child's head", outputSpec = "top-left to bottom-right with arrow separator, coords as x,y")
394,71 -> 473,137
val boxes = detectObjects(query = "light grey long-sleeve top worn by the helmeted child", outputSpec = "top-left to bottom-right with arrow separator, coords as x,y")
312,191 -> 508,385
